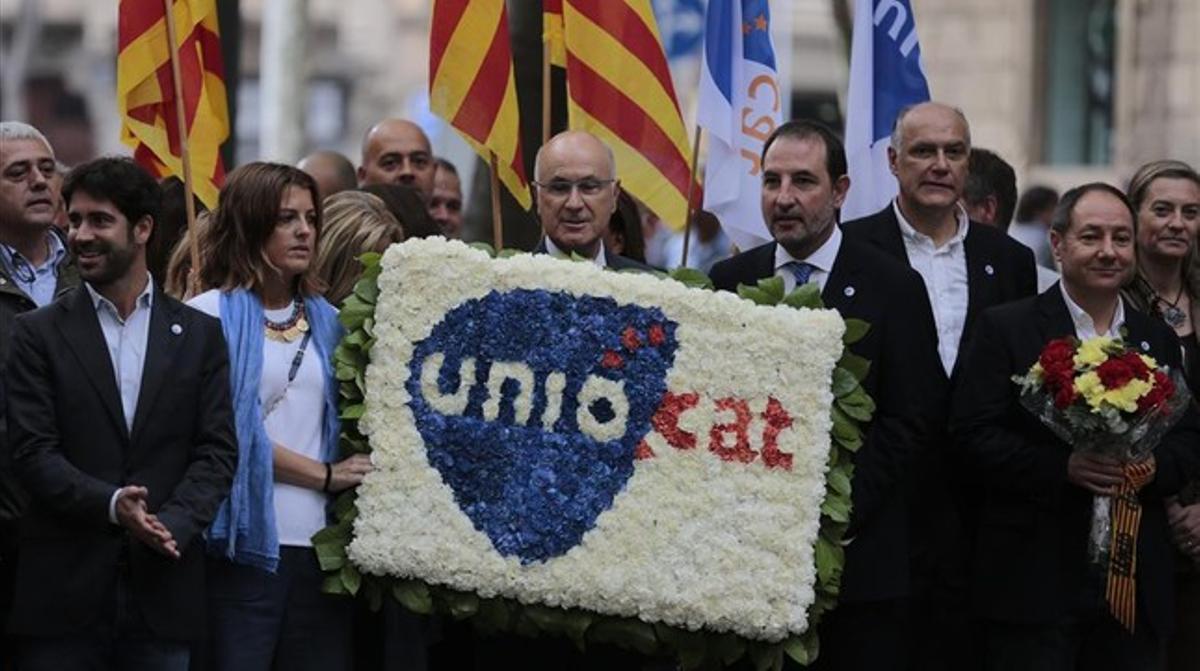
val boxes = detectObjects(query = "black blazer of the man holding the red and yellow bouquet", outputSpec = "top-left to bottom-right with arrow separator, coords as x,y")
950,289 -> 1200,636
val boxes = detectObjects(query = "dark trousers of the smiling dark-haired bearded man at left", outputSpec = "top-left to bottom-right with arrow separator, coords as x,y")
17,575 -> 190,671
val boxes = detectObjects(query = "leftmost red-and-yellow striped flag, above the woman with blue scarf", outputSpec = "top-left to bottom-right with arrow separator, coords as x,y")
116,0 -> 229,208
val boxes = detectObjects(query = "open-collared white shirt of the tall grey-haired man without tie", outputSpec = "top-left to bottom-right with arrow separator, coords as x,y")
892,200 -> 970,375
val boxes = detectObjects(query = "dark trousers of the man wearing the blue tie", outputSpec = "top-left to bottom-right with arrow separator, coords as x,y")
784,599 -> 911,671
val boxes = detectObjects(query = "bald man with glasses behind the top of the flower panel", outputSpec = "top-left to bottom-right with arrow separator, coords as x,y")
533,131 -> 653,270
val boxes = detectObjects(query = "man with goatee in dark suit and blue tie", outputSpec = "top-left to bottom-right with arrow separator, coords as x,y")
712,121 -> 944,670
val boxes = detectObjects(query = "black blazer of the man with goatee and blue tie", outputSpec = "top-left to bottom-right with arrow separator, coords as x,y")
712,238 -> 946,601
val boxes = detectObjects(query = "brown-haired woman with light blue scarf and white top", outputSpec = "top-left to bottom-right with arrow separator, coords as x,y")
188,163 -> 371,671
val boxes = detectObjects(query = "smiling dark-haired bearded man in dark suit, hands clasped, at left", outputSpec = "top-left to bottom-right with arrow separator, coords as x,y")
5,158 -> 238,670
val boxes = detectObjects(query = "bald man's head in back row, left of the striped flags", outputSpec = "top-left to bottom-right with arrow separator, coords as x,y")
359,119 -> 437,201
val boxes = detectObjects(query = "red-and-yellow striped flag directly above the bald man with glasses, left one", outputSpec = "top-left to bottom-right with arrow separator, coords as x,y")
430,0 -> 533,209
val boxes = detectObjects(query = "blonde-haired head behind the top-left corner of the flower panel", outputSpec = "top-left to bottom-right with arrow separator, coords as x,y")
317,191 -> 404,305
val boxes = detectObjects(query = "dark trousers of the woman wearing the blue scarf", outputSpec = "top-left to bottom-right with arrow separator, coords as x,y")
206,546 -> 354,671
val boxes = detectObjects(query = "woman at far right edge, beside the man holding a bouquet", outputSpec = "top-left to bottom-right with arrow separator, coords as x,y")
1124,161 -> 1200,671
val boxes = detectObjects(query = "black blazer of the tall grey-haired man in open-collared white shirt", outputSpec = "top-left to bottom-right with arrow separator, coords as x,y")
841,203 -> 1038,381
